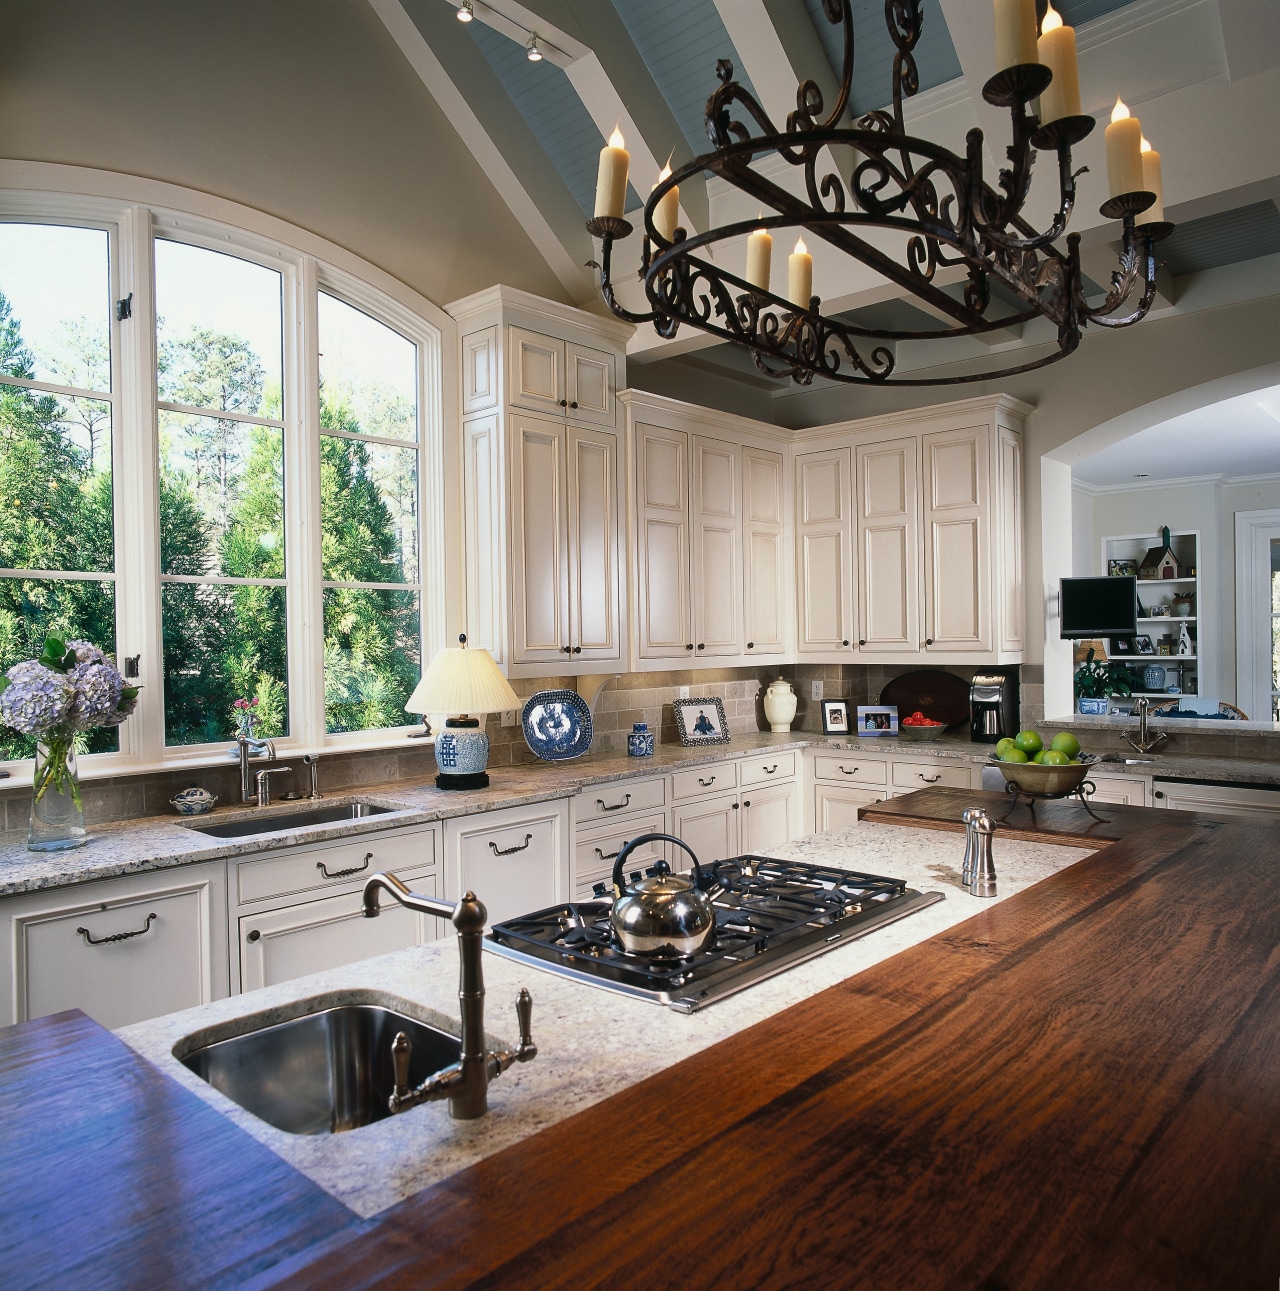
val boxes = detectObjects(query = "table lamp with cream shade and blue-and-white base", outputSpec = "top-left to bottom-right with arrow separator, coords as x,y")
404,635 -> 521,789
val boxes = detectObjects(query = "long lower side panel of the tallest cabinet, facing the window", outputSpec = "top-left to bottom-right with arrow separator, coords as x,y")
462,413 -> 508,665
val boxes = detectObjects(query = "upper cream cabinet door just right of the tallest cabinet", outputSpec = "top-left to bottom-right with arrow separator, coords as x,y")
635,422 -> 694,658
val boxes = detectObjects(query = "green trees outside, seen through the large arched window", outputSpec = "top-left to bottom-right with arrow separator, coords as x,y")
0,287 -> 421,758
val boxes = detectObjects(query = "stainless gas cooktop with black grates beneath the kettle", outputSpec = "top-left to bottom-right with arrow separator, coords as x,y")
484,856 -> 943,1013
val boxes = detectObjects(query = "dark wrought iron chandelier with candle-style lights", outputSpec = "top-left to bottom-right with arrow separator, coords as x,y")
586,0 -> 1173,386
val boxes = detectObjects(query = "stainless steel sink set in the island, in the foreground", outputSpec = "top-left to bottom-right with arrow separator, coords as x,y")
174,1002 -> 462,1135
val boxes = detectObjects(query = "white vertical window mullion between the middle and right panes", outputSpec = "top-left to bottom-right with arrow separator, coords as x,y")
284,257 -> 324,747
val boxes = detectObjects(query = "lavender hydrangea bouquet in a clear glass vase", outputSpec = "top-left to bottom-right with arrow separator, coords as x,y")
0,633 -> 138,837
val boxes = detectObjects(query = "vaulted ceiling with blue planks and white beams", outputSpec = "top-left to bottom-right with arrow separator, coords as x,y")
369,0 -> 1280,413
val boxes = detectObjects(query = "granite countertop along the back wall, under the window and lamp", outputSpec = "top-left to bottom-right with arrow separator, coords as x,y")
0,719 -> 1280,897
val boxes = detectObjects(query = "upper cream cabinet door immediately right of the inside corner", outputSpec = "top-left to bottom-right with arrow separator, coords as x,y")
796,448 -> 854,655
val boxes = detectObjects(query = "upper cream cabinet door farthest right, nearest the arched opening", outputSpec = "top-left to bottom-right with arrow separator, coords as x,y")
922,426 -> 992,653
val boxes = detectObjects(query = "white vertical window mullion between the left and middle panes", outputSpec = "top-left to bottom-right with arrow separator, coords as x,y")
111,207 -> 164,766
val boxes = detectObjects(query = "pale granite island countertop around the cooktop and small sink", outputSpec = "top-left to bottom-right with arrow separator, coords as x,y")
118,822 -> 1090,1217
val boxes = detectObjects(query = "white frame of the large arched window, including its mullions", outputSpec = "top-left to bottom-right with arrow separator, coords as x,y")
0,183 -> 456,785
